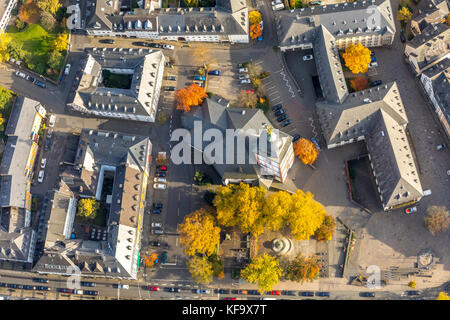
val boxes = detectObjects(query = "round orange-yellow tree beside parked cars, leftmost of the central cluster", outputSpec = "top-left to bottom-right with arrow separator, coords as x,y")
178,209 -> 220,256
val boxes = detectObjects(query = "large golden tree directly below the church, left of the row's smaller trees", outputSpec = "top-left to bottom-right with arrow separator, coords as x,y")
214,183 -> 266,237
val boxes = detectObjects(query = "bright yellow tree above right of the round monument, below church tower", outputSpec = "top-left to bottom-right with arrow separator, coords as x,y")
286,190 -> 326,240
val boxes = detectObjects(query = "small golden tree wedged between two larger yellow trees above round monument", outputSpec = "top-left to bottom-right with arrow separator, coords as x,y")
263,191 -> 292,231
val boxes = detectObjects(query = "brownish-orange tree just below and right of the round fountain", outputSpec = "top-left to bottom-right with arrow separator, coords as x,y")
283,253 -> 321,283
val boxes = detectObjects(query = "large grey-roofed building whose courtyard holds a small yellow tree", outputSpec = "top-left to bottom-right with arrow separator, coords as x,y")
33,130 -> 152,279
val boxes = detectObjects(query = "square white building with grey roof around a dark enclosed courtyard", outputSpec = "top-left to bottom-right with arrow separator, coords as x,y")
68,48 -> 165,122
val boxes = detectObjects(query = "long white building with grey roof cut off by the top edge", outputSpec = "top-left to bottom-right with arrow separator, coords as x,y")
85,0 -> 249,43
